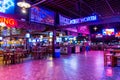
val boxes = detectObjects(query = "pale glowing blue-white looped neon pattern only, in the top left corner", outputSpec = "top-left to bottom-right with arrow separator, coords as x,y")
0,0 -> 14,13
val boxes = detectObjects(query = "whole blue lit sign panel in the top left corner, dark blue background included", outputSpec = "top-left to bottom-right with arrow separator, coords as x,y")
0,0 -> 15,14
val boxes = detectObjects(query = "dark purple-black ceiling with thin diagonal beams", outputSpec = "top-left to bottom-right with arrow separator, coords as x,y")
29,0 -> 120,18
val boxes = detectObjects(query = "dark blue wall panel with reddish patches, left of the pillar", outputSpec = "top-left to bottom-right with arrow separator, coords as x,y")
30,7 -> 54,25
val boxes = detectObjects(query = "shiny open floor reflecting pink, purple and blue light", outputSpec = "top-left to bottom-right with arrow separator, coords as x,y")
0,51 -> 120,80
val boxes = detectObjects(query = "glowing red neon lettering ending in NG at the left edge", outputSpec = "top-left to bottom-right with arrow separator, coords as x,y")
0,17 -> 17,27
